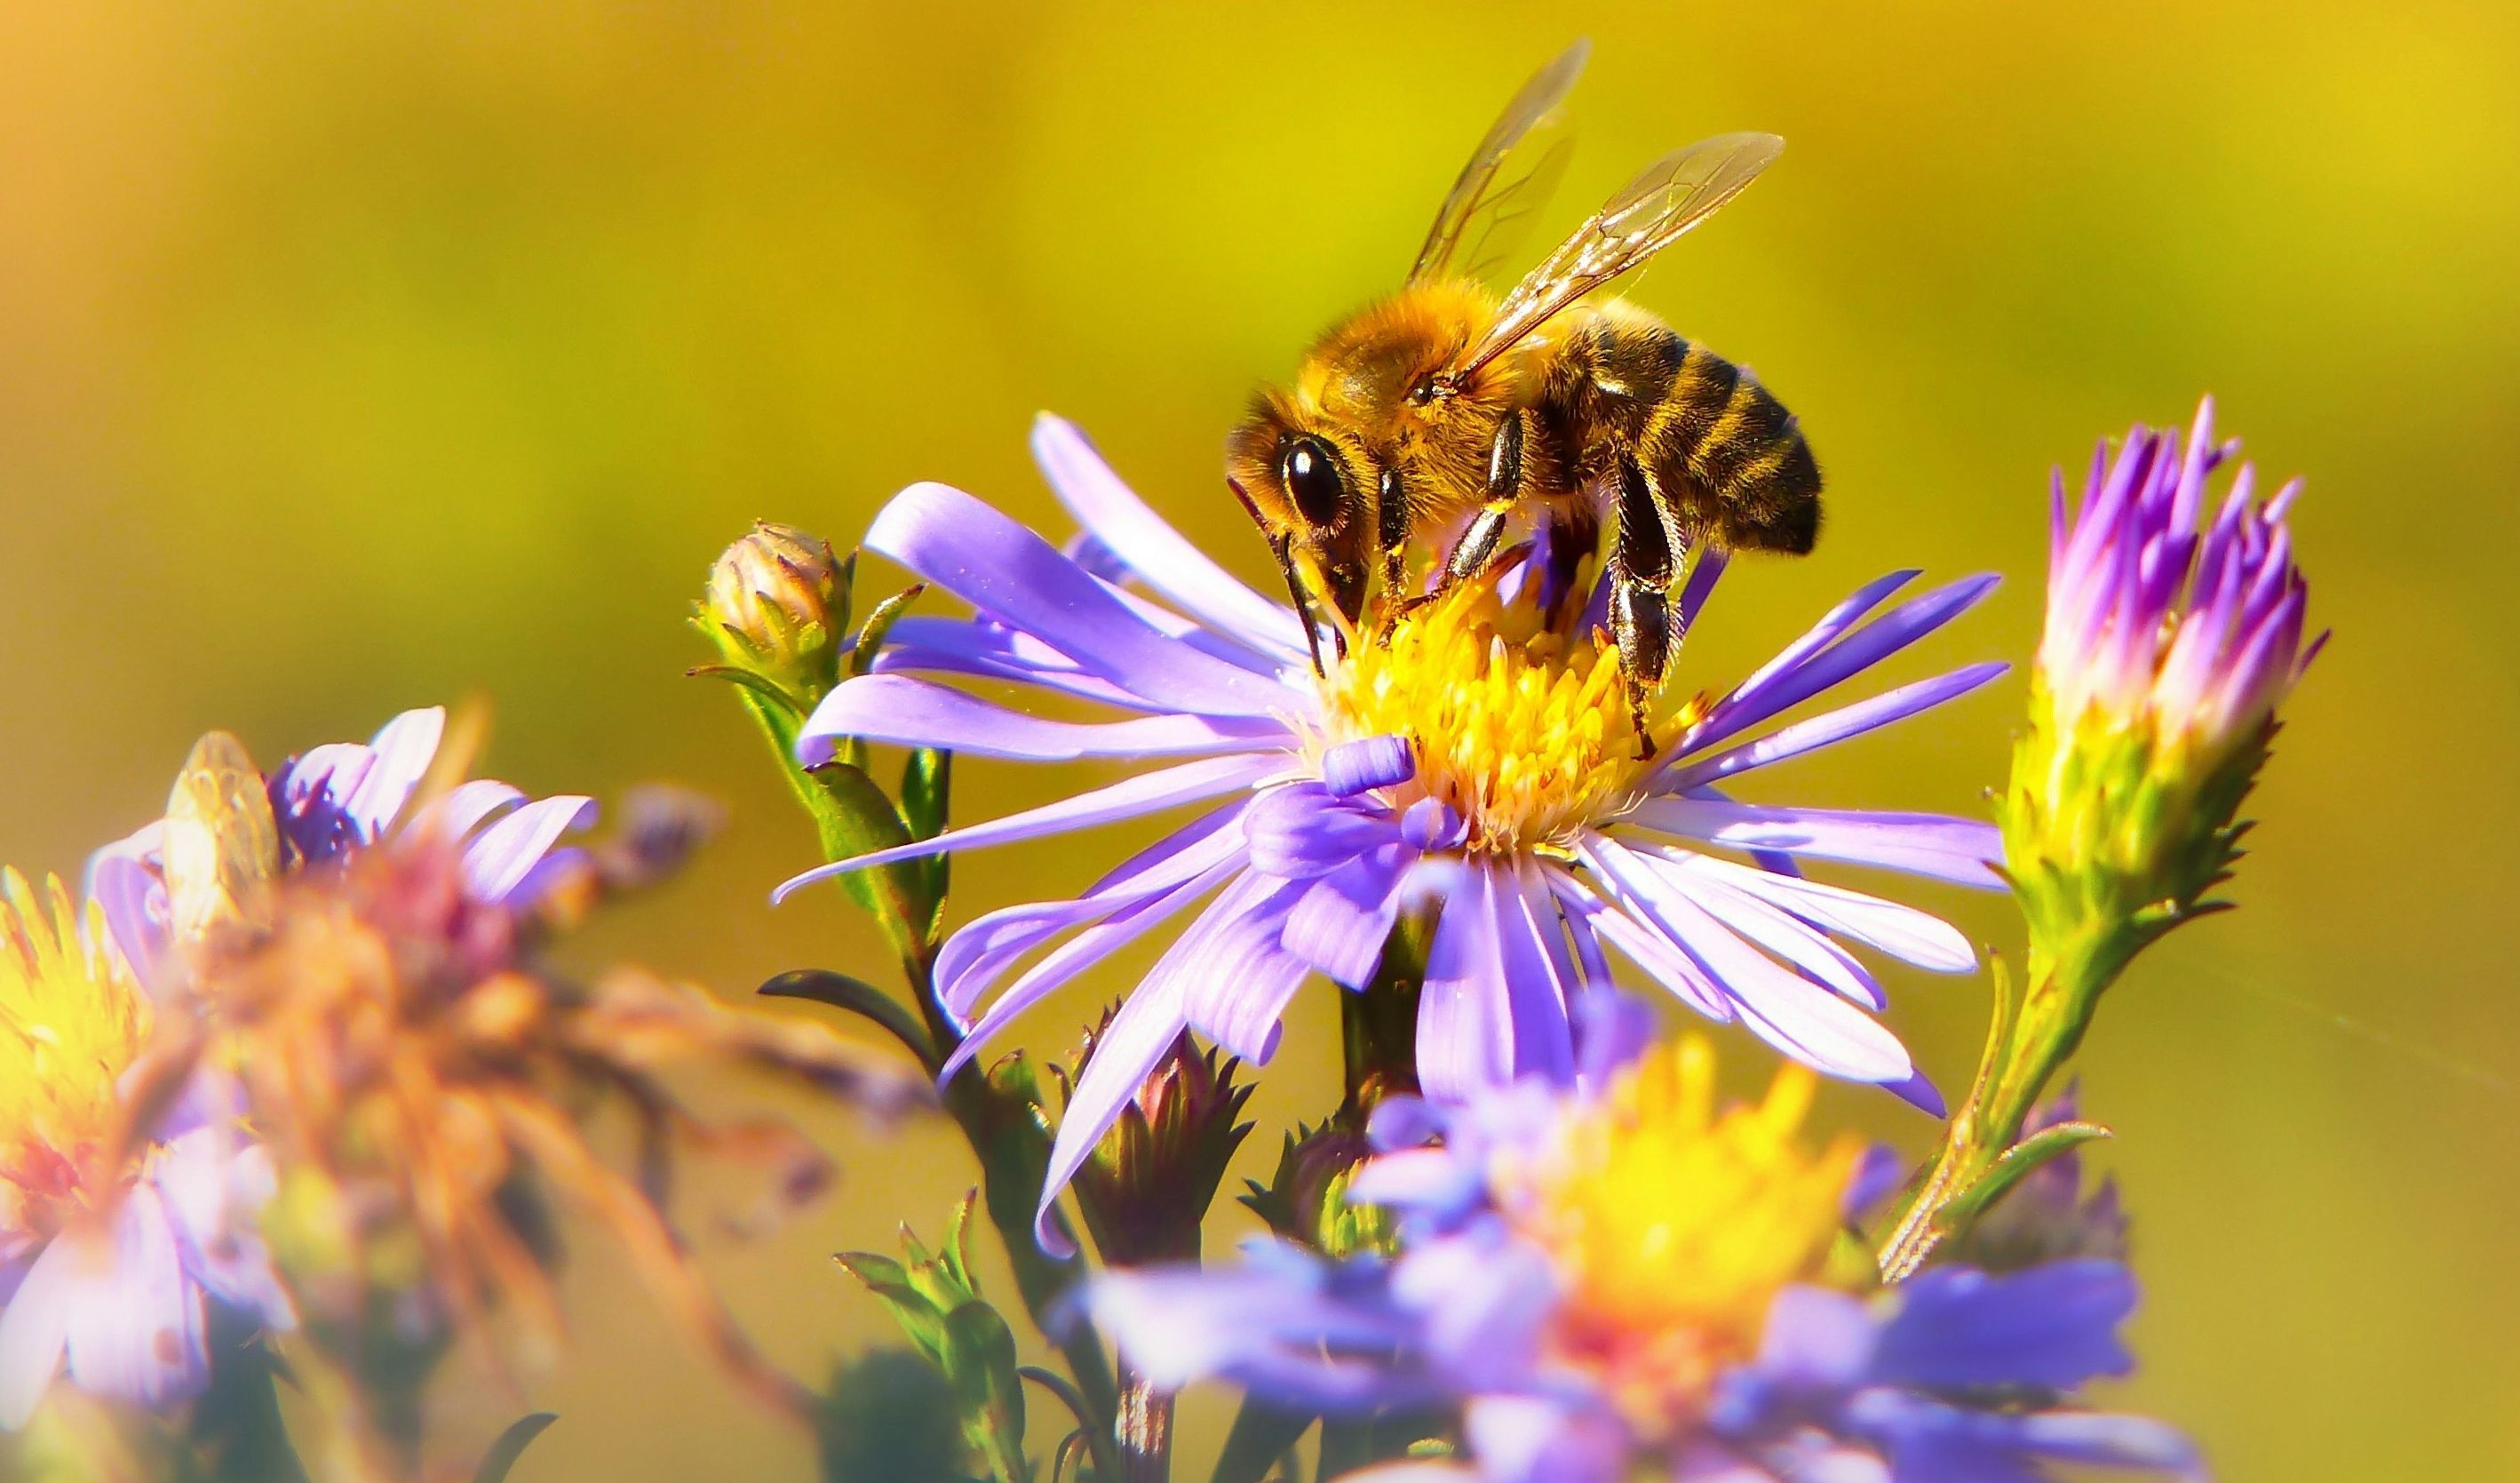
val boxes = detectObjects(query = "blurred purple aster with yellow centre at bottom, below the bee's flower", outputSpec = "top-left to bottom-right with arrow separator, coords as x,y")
1086,996 -> 2195,1483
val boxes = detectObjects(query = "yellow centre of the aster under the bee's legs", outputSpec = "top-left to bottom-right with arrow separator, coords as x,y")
1323,580 -> 1698,855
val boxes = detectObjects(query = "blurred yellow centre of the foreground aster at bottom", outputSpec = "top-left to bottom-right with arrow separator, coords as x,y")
1497,1037 -> 1860,1428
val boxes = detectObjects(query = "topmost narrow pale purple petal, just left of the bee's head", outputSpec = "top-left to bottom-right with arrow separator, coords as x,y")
1033,414 -> 1306,661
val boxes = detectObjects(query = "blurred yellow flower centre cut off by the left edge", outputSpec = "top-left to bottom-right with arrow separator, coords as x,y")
0,870 -> 148,1248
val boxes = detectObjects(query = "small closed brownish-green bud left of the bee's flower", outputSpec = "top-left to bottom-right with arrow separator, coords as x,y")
693,520 -> 852,706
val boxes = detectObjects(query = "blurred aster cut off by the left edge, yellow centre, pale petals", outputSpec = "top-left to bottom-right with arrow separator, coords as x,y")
0,870 -> 292,1428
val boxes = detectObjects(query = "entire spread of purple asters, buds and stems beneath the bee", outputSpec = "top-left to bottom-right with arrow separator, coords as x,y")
0,395 -> 2316,1483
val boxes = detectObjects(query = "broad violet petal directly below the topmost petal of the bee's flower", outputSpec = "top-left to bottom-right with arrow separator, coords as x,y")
867,484 -> 1288,716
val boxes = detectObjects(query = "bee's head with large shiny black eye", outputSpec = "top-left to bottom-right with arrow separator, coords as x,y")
1225,394 -> 1376,628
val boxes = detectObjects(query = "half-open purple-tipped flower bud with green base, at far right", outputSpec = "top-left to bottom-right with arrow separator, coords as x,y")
2003,401 -> 2318,976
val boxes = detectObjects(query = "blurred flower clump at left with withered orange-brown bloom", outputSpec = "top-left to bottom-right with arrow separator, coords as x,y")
0,709 -> 920,1475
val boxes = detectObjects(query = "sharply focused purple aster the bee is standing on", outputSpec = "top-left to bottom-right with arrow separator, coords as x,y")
779,419 -> 2001,1243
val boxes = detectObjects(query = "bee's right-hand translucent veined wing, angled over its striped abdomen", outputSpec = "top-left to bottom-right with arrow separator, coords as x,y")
1457,133 -> 1785,376
